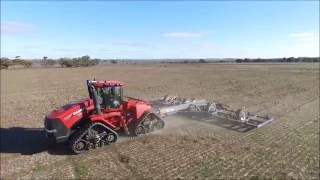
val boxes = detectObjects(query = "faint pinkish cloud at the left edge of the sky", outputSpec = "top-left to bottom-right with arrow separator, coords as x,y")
1,21 -> 37,35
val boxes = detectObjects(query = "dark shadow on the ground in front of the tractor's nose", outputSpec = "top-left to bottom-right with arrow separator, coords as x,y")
0,127 -> 72,155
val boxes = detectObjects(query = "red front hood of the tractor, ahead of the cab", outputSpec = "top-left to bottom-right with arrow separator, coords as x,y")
46,98 -> 94,128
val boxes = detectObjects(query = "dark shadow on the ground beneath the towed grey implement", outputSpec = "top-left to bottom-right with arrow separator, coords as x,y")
178,112 -> 256,133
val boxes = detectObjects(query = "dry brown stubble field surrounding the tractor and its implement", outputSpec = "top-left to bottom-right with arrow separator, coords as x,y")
1,63 -> 319,179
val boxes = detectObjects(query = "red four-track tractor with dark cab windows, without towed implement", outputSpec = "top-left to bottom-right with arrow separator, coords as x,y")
44,80 -> 164,154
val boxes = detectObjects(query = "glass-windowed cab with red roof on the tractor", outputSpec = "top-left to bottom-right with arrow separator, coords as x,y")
87,80 -> 123,113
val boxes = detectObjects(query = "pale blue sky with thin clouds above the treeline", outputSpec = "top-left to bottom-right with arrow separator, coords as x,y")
1,1 -> 319,59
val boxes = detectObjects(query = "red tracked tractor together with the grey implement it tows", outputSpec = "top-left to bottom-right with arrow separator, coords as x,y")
44,80 -> 273,154
